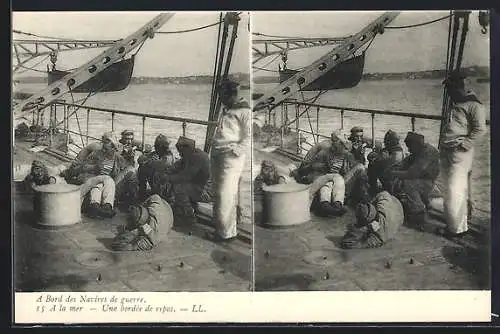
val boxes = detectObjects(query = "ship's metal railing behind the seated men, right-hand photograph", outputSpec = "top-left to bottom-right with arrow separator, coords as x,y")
267,100 -> 442,156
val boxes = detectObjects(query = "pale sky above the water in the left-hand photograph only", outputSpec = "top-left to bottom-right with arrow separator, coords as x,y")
12,11 -> 250,77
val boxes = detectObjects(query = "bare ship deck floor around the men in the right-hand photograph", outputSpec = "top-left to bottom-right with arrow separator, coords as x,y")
253,149 -> 490,291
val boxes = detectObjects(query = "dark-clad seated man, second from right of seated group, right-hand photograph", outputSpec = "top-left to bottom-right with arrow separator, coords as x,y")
368,129 -> 404,194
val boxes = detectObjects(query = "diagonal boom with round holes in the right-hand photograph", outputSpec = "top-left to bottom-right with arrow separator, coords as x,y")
254,12 -> 399,111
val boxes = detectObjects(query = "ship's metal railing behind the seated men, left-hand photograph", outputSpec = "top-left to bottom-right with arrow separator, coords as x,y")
39,100 -> 215,154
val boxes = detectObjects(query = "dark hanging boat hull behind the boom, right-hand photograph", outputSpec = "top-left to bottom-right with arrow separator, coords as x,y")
279,53 -> 365,91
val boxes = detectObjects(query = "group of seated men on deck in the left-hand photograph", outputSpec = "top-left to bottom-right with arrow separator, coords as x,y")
25,130 -> 213,250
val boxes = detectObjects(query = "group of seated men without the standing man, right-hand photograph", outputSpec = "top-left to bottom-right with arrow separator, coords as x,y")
254,126 -> 439,248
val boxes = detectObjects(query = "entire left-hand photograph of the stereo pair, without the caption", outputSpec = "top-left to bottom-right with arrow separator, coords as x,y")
11,12 -> 253,292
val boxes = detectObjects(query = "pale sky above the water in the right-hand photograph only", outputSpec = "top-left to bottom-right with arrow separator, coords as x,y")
252,11 -> 490,76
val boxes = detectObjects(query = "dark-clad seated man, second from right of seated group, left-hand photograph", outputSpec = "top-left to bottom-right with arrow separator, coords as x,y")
137,134 -> 175,198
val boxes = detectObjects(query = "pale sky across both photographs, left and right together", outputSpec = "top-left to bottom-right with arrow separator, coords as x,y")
12,11 -> 489,77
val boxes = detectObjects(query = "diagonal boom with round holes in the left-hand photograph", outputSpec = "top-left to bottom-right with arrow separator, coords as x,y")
14,13 -> 174,123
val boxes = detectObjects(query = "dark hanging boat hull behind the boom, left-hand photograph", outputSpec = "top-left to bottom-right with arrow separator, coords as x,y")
48,58 -> 134,93
